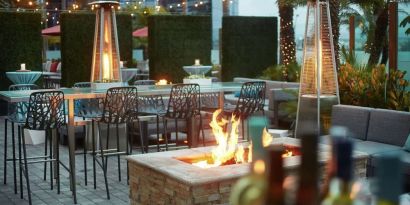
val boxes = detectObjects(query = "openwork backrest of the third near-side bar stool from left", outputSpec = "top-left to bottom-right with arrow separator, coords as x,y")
165,84 -> 201,119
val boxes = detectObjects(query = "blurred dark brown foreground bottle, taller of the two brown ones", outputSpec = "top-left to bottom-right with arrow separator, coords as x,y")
295,134 -> 319,205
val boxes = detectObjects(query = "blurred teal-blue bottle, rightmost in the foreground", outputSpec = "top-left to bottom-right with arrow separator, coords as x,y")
375,153 -> 403,205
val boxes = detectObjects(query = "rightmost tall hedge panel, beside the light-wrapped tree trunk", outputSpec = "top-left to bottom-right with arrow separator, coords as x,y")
222,16 -> 278,81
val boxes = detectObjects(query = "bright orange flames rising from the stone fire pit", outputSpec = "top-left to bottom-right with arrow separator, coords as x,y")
193,109 -> 273,168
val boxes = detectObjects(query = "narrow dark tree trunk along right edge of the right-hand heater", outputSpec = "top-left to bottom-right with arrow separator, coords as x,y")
329,0 -> 340,69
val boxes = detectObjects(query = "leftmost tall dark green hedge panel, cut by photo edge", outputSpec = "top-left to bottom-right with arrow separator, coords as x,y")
0,12 -> 43,90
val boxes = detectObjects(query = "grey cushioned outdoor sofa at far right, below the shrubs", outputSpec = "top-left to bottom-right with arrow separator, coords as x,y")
328,105 -> 410,190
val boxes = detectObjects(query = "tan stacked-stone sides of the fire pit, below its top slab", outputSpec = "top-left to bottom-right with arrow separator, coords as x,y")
129,157 -> 367,205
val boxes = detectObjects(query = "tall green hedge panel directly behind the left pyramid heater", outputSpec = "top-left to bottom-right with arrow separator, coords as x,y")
60,13 -> 132,87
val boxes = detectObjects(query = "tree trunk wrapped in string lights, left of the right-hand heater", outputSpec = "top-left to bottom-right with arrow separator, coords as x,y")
278,0 -> 296,65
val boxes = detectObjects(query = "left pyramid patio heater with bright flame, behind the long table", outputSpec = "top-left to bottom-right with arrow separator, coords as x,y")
90,1 -> 122,89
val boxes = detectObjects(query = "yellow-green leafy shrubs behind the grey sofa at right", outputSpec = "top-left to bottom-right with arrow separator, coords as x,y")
338,64 -> 410,111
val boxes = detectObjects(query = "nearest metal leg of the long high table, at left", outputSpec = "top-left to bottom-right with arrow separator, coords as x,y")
67,99 -> 77,204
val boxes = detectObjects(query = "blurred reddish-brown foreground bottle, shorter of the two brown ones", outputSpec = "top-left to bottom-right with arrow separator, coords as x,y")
265,145 -> 285,205
